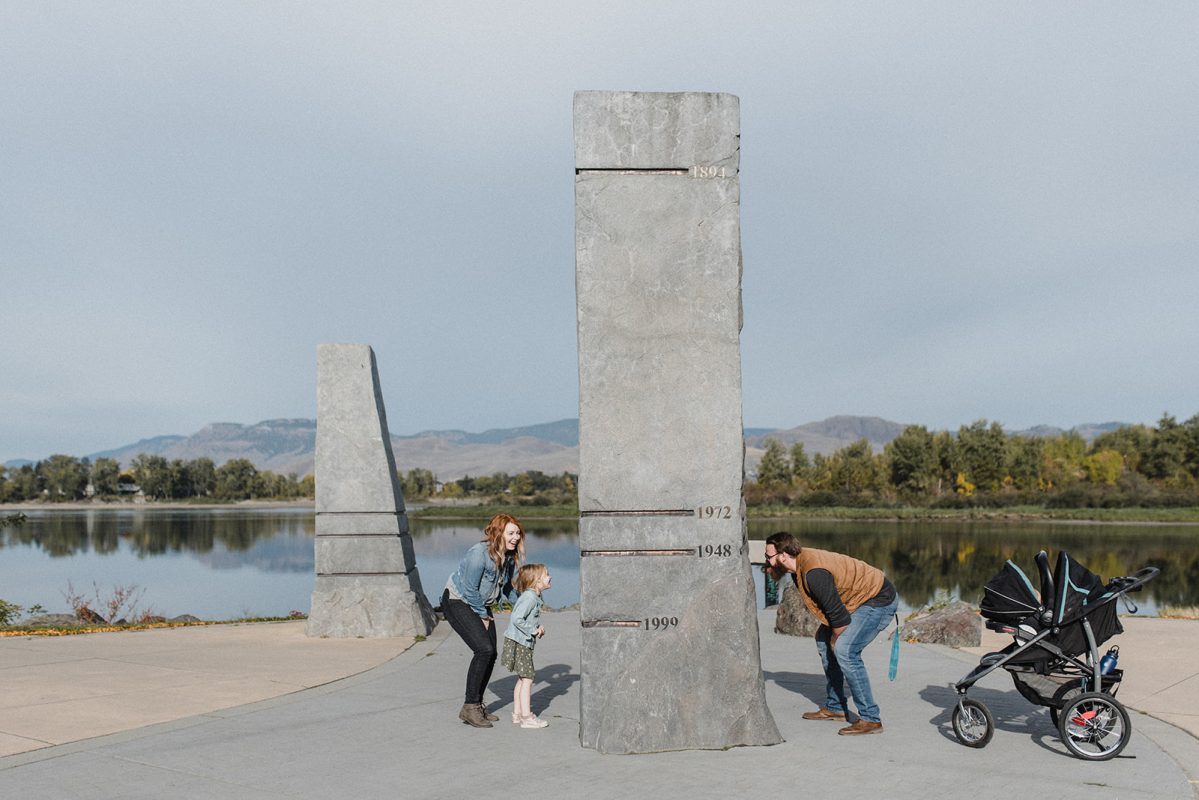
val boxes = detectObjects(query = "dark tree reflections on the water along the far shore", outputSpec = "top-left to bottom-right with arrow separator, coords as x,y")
11,510 -> 1199,607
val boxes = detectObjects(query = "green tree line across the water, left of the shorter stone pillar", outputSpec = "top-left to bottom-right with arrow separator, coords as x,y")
0,453 -> 315,503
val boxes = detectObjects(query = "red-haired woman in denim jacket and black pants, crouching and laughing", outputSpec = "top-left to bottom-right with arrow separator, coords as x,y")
441,513 -> 524,728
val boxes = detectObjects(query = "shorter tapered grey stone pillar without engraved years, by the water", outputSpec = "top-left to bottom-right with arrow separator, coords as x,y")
307,344 -> 436,638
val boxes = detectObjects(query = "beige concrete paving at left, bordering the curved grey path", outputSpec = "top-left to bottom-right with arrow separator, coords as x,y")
0,621 -> 414,756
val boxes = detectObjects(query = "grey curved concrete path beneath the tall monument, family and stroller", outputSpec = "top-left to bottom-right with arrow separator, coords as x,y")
0,610 -> 1199,800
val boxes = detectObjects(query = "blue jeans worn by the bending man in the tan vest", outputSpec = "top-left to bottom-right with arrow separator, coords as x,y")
817,596 -> 899,722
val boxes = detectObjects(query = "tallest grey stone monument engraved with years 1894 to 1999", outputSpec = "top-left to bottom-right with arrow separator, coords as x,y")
574,91 -> 782,753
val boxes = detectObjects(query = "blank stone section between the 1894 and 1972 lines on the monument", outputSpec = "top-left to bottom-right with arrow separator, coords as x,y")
576,173 -> 743,511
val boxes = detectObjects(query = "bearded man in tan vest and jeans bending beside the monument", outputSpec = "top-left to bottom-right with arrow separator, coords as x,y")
766,531 -> 899,736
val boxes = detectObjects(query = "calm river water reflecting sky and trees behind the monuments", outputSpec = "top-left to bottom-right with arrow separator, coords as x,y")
0,507 -> 1199,619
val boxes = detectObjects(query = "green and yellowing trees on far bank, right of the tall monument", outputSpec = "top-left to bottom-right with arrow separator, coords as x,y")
746,414 -> 1199,509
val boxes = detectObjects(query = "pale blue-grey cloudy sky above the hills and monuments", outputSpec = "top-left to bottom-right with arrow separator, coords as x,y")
0,0 -> 1199,462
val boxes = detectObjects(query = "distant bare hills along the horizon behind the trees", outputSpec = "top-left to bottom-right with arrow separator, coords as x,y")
63,416 -> 1123,481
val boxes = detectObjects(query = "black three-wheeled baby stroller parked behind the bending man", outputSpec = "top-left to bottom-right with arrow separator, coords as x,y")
953,551 -> 1158,760
